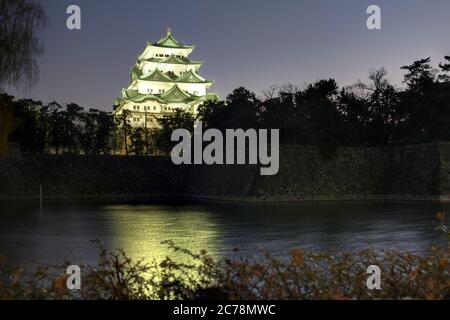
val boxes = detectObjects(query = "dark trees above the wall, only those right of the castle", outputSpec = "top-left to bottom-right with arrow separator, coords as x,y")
200,57 -> 450,145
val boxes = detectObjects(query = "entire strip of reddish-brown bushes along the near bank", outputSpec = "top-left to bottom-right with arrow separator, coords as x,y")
0,241 -> 450,299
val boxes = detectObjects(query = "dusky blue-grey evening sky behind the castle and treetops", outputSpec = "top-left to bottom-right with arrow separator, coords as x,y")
7,0 -> 450,110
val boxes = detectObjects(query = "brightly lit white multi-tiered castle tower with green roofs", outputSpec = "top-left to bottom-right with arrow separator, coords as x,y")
114,28 -> 218,127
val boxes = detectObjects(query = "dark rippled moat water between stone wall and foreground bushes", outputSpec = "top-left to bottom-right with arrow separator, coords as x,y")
0,203 -> 448,264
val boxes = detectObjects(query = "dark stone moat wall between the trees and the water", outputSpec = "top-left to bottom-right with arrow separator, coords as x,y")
0,143 -> 450,201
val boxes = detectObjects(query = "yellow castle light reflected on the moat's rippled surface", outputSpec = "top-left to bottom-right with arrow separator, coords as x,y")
103,205 -> 223,262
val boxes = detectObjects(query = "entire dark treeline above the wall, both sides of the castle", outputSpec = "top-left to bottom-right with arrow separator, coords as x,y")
1,56 -> 450,155
